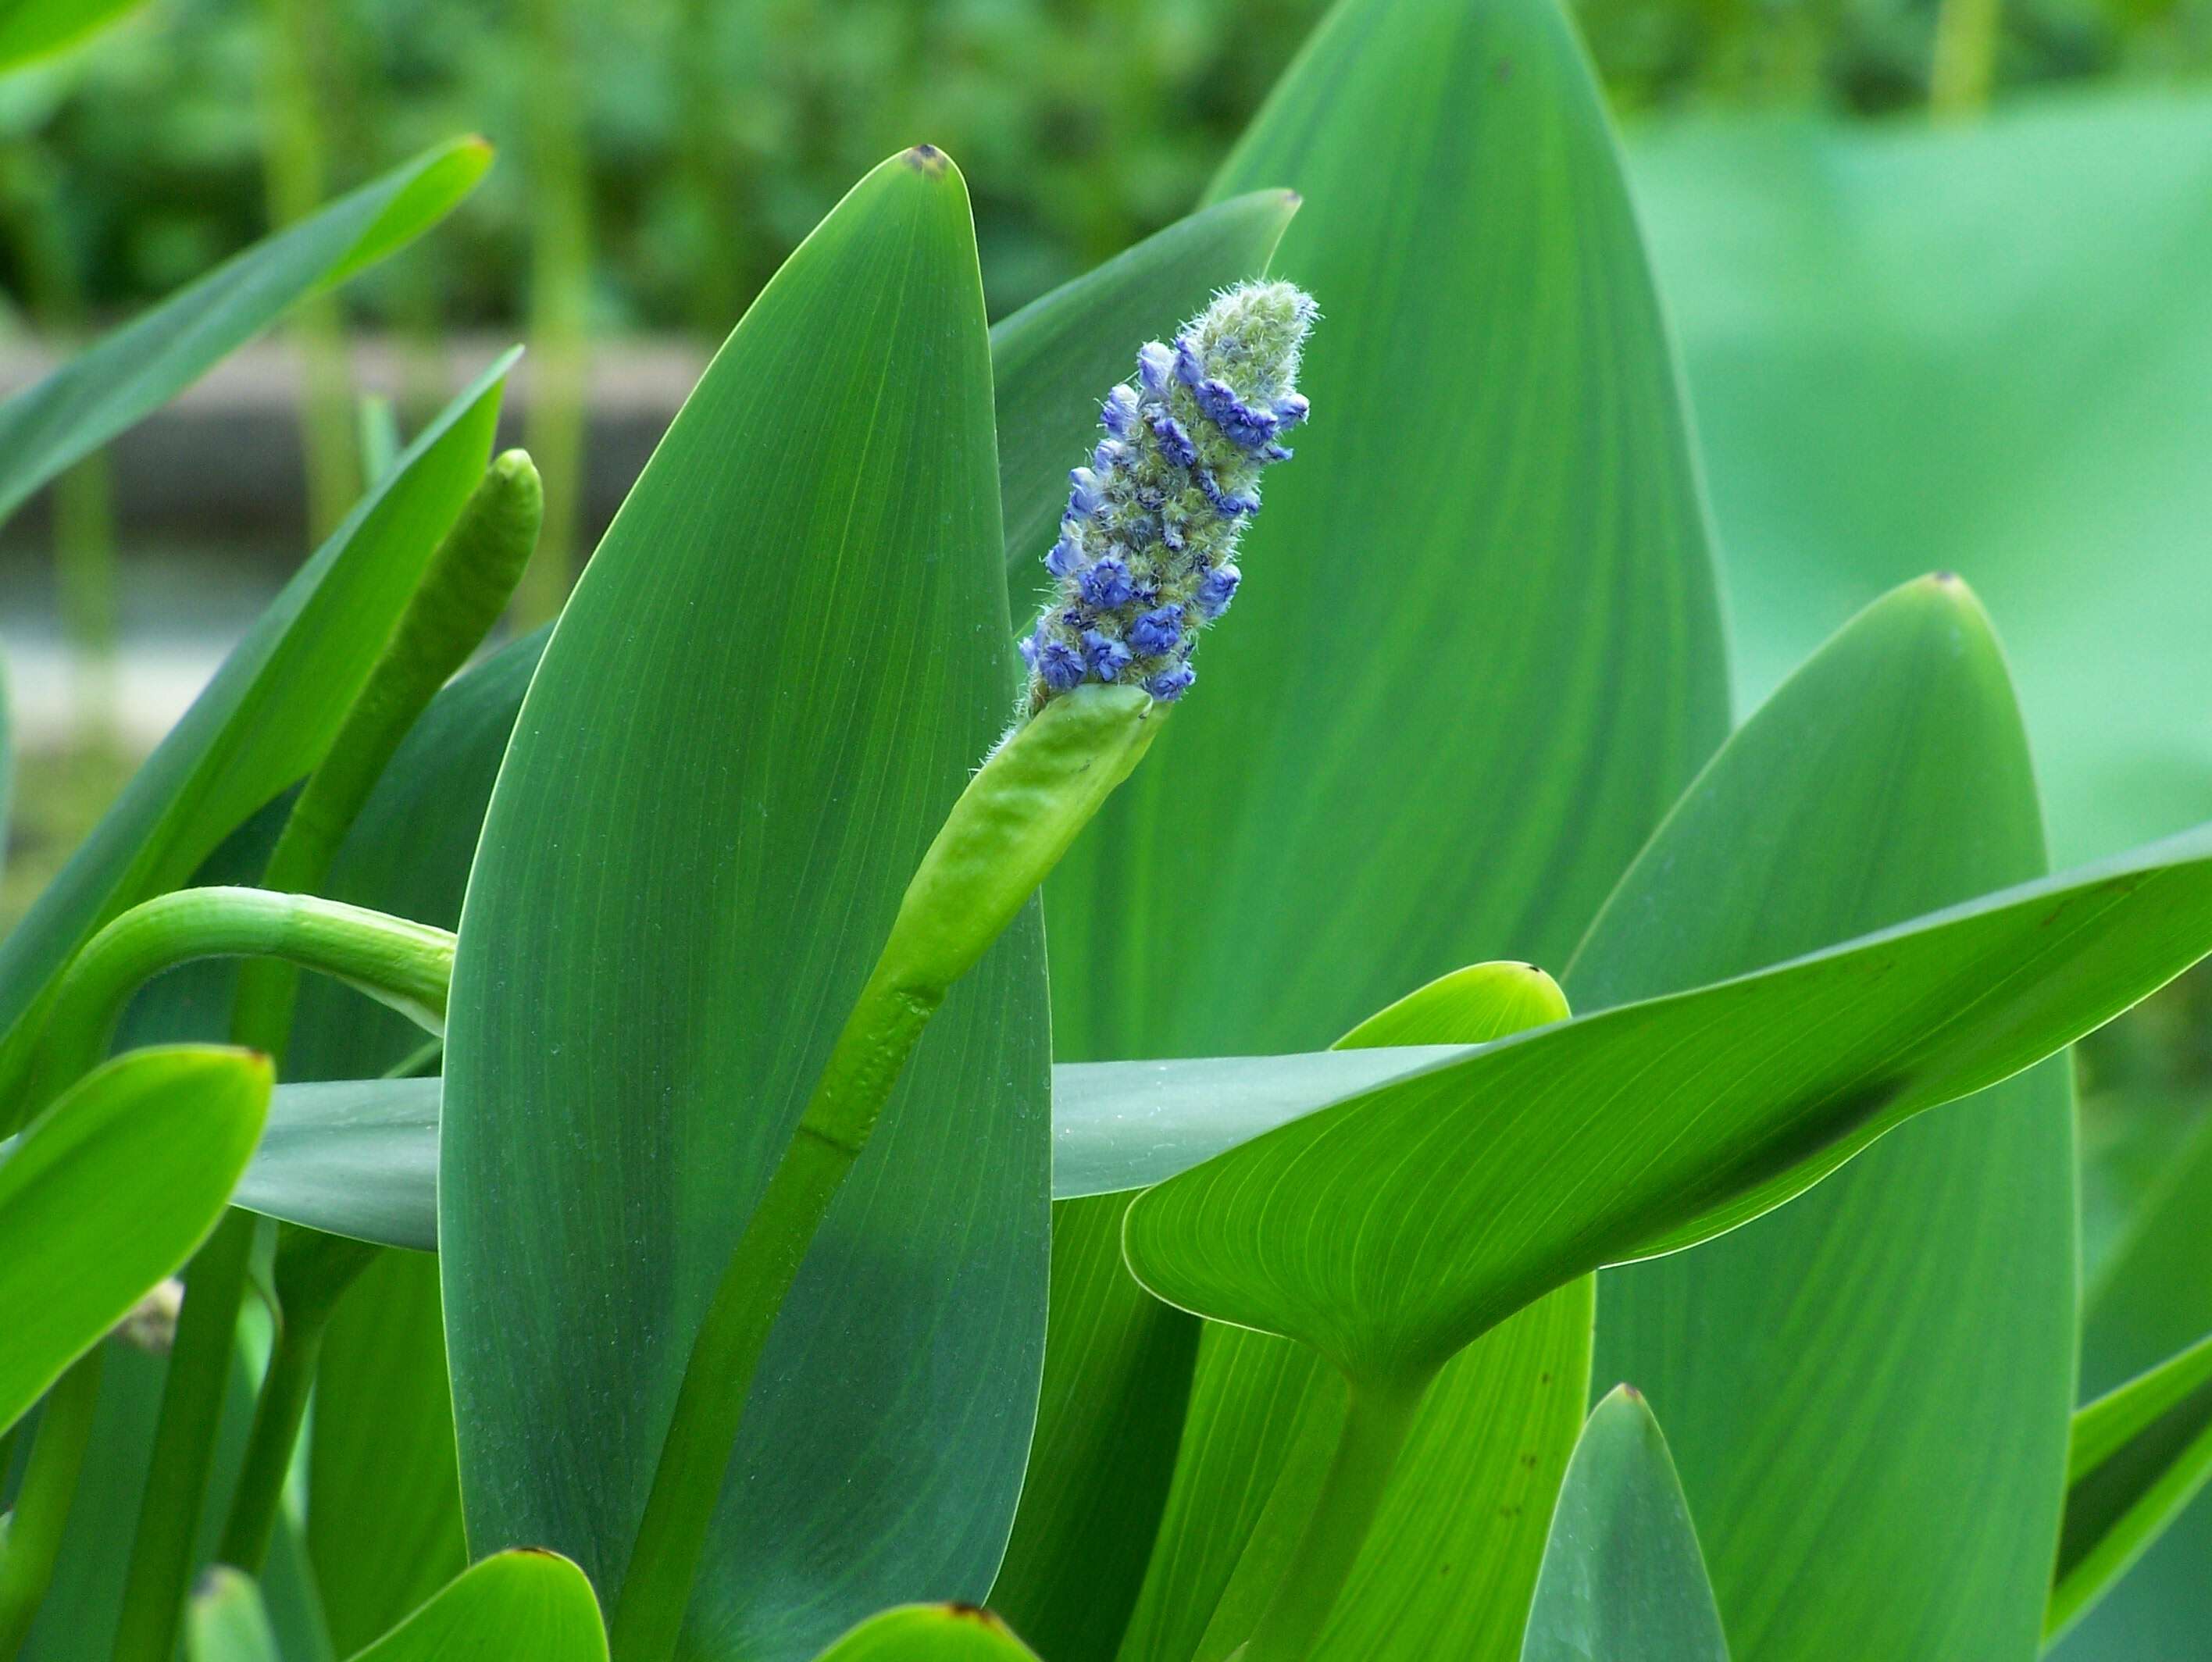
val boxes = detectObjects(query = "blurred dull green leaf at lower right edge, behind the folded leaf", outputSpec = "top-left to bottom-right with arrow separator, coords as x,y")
2053,1106 -> 2212,1662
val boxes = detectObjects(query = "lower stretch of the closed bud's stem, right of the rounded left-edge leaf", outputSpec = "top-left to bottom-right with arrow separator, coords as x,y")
115,1211 -> 255,1662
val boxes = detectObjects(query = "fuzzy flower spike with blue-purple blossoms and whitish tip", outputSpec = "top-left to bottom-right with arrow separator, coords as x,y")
1022,284 -> 1314,712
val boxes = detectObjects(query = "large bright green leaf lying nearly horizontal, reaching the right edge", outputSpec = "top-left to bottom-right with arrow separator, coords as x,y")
1126,828 -> 2212,1378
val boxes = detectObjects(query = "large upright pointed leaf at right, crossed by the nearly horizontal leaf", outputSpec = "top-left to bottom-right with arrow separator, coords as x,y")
1566,578 -> 2075,1662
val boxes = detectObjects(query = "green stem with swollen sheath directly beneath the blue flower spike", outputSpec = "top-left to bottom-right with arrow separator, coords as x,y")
608,688 -> 1165,1662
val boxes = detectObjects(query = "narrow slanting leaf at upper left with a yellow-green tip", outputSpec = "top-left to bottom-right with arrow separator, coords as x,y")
0,144 -> 491,535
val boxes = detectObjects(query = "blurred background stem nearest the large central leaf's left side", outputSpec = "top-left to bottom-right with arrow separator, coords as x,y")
516,0 -> 590,629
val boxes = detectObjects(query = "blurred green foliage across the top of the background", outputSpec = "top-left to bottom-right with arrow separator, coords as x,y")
0,0 -> 2212,337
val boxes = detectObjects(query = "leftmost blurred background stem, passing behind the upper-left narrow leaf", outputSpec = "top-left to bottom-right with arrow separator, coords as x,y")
0,135 -> 122,751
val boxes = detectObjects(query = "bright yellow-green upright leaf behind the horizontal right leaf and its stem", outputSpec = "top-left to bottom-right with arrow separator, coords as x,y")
1122,965 -> 1590,1662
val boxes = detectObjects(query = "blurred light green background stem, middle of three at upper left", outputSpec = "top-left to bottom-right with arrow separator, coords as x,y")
261,0 -> 361,544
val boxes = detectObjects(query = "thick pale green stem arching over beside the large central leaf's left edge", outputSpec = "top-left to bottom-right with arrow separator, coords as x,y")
24,887 -> 454,1118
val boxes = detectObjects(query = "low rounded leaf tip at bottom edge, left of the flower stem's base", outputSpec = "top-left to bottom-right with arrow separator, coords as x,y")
354,1547 -> 606,1662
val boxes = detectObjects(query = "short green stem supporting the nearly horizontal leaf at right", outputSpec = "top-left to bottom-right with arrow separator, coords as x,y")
1236,1376 -> 1429,1662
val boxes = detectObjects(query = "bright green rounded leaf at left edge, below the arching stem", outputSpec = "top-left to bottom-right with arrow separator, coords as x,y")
0,1047 -> 270,1429
